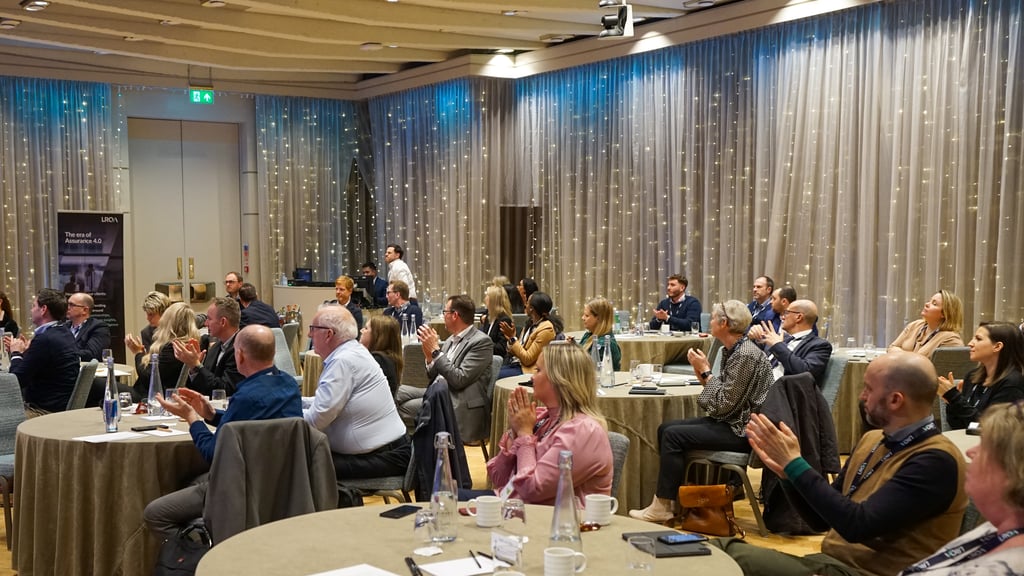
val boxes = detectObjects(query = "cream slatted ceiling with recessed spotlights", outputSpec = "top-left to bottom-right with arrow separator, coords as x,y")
0,0 -> 753,95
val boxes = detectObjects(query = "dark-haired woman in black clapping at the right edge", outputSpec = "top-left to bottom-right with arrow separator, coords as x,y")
938,322 -> 1024,430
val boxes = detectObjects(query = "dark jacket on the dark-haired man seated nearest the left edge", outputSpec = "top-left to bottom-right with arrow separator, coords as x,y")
10,324 -> 79,412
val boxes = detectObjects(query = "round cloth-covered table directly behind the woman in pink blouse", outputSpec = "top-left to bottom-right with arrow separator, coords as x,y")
490,372 -> 705,515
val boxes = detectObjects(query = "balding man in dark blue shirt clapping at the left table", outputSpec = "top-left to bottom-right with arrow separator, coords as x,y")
142,325 -> 302,540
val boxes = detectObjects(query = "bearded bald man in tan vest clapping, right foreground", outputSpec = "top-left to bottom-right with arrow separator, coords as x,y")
718,353 -> 967,576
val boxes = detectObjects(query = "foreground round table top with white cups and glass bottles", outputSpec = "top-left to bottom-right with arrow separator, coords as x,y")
196,505 -> 741,576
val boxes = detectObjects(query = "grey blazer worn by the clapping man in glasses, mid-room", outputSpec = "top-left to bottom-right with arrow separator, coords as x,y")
427,329 -> 494,442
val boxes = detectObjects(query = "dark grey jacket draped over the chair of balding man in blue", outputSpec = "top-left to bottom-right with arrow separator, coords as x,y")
203,418 -> 338,542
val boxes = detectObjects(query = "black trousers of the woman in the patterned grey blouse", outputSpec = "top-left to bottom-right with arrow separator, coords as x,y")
655,417 -> 751,500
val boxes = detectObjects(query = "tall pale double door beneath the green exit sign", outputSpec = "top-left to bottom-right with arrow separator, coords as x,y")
128,118 -> 242,313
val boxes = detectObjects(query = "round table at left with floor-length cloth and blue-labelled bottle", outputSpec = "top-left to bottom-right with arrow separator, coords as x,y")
11,408 -> 208,576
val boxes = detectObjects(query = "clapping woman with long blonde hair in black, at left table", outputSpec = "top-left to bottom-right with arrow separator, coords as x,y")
125,302 -> 200,400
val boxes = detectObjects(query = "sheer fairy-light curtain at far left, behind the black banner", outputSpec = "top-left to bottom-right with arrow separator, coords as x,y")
0,77 -> 114,322
